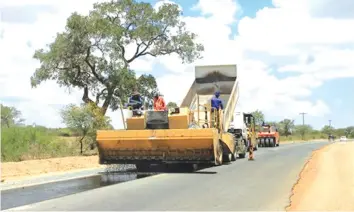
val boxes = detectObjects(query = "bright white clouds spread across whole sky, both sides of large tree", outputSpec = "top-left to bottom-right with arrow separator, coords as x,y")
0,0 -> 354,129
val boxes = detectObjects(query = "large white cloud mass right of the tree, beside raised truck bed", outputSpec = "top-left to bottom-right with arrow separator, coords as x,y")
153,0 -> 354,121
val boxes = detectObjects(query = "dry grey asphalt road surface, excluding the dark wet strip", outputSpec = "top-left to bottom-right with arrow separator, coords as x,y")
9,142 -> 328,211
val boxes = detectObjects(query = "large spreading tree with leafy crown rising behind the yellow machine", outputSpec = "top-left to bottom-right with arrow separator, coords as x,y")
31,0 -> 204,114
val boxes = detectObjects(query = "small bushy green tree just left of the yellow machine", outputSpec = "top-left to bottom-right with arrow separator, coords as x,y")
60,103 -> 110,154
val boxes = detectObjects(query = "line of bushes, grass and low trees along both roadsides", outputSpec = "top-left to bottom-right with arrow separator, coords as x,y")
0,102 -> 354,161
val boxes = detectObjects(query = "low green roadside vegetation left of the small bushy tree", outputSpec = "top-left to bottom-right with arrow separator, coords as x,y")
1,126 -> 75,162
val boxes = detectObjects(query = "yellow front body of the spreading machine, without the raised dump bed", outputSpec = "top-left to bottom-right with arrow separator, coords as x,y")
97,108 -> 221,164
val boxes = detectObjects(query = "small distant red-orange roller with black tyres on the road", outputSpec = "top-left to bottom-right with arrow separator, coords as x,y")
257,124 -> 280,147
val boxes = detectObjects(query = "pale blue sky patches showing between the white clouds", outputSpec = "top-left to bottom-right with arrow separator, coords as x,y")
147,0 -> 354,128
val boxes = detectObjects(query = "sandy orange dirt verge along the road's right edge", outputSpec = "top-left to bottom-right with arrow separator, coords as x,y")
286,142 -> 354,211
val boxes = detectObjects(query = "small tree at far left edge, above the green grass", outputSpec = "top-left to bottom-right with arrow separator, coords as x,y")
0,104 -> 24,128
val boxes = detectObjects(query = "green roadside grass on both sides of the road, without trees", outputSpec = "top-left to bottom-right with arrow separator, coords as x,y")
1,126 -> 334,162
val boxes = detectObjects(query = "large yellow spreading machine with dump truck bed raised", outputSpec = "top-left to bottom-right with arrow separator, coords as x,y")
96,65 -> 239,171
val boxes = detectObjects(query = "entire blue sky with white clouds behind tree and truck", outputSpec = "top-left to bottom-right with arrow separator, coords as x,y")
0,0 -> 354,129
